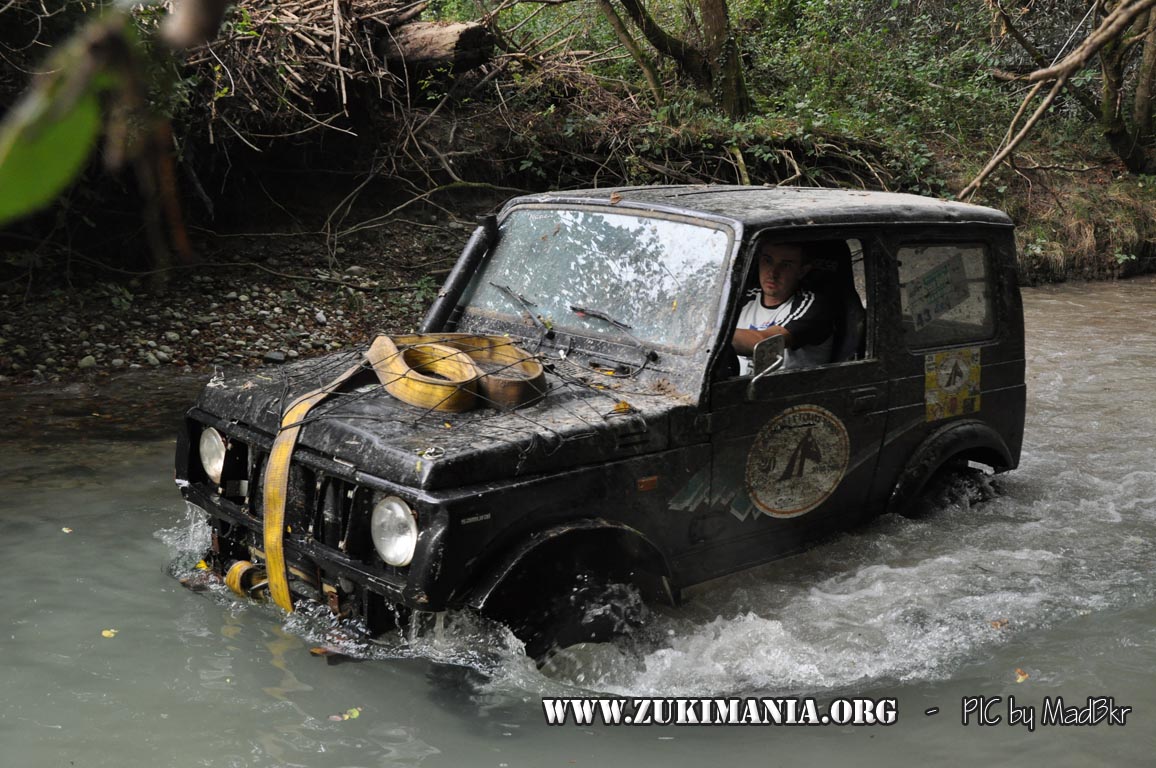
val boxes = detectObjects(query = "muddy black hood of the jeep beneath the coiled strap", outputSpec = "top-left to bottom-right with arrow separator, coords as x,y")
198,354 -> 694,490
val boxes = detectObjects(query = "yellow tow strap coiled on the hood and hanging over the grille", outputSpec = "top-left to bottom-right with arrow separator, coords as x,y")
264,333 -> 546,612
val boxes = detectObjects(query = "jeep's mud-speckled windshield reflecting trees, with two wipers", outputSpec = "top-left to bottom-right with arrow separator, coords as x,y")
462,208 -> 731,350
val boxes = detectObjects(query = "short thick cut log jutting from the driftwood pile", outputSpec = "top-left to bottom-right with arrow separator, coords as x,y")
380,21 -> 494,72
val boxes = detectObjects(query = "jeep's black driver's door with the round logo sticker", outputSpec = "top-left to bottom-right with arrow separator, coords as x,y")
677,232 -> 889,582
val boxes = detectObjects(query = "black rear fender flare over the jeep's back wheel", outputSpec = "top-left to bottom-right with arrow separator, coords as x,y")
887,419 -> 1014,512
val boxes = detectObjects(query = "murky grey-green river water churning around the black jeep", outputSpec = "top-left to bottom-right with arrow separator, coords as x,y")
0,279 -> 1156,768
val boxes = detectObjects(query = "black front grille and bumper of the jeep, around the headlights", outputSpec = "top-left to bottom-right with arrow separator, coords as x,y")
177,409 -> 450,625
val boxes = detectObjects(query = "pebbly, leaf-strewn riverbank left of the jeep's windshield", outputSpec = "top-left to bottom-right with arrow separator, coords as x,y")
0,222 -> 469,384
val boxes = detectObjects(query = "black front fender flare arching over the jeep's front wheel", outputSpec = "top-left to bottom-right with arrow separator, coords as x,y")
466,518 -> 674,613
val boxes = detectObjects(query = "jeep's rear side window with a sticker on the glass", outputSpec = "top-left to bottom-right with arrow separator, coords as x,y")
899,243 -> 995,349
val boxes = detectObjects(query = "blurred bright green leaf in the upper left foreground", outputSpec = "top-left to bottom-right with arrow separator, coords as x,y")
0,84 -> 101,227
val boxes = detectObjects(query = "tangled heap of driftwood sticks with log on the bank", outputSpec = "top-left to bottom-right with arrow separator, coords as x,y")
178,0 -> 494,139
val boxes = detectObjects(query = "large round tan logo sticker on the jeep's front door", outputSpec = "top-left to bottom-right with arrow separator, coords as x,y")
747,405 -> 851,517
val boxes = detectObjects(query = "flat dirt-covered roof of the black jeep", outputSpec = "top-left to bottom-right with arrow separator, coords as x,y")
506,184 -> 1012,228
